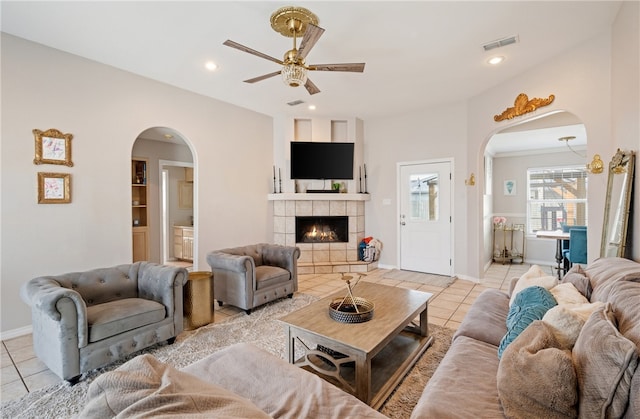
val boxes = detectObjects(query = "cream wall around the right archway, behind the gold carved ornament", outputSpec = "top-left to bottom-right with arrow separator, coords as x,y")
467,32 -> 611,278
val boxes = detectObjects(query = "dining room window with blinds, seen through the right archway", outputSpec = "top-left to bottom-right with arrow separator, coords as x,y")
527,166 -> 587,234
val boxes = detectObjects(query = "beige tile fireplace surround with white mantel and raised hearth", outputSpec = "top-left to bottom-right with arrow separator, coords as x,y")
269,193 -> 378,274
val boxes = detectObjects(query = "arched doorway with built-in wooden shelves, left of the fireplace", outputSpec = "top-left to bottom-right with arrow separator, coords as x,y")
131,127 -> 197,268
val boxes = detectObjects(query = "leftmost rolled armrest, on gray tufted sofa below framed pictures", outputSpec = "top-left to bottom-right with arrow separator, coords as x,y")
20,277 -> 89,348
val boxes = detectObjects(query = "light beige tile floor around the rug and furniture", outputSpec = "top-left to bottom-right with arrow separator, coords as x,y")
0,264 -> 553,402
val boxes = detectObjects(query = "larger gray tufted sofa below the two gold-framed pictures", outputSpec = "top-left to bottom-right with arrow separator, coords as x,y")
20,262 -> 189,384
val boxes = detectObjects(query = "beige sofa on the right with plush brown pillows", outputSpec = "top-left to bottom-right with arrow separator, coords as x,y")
412,258 -> 640,419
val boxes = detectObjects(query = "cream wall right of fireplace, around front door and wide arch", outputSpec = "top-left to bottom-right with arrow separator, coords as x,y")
365,20 -> 640,279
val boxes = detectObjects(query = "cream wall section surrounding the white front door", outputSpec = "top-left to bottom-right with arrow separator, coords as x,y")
364,103 -> 470,274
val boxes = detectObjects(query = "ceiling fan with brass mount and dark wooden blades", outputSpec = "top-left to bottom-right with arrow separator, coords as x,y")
223,6 -> 364,95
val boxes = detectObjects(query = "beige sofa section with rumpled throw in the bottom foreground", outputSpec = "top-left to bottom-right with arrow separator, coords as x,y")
78,343 -> 385,419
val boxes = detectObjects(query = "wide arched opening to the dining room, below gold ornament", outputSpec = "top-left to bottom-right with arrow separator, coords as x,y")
482,111 -> 587,270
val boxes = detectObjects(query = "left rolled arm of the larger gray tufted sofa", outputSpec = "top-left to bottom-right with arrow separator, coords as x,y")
20,277 -> 88,347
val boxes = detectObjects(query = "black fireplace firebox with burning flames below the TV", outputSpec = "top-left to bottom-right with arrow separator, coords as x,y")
296,216 -> 349,243
